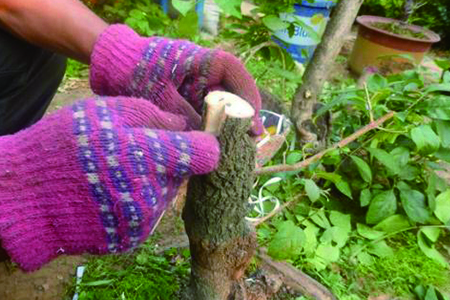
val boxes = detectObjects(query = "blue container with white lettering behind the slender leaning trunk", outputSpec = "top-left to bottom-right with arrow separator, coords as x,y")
273,0 -> 336,63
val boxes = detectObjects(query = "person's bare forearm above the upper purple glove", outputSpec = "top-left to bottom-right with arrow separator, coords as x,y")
0,0 -> 108,63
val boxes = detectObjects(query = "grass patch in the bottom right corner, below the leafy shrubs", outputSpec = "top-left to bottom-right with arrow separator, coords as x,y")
312,232 -> 450,300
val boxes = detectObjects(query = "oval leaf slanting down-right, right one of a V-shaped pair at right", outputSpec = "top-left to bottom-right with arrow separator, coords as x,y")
397,182 -> 431,224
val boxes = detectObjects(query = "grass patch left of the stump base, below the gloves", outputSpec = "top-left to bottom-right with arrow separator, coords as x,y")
67,240 -> 190,300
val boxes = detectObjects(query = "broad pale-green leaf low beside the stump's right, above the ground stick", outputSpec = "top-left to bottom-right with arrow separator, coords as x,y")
268,221 -> 306,259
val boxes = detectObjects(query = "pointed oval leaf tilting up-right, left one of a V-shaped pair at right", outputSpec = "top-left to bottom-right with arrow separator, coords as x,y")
366,190 -> 397,224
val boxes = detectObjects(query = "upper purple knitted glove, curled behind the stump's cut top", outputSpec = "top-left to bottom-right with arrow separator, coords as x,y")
90,25 -> 262,135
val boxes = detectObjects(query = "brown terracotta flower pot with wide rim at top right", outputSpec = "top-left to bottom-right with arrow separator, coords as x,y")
349,16 -> 440,74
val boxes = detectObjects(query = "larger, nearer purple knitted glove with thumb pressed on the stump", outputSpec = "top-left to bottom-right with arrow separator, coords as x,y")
0,97 -> 220,271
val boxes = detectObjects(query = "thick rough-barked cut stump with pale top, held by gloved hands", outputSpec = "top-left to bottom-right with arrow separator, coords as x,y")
183,92 -> 256,300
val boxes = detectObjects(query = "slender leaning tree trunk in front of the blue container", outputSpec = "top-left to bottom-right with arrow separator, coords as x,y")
291,0 -> 363,147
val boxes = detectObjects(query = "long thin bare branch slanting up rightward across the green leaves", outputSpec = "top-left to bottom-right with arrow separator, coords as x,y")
255,111 -> 395,175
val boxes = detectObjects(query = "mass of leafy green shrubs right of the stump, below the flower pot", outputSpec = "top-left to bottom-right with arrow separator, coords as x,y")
258,62 -> 450,298
